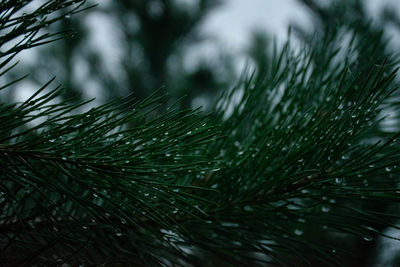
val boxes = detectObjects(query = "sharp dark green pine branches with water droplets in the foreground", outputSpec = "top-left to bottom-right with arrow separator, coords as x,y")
0,0 -> 400,266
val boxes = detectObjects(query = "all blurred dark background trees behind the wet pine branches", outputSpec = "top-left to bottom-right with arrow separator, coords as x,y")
3,0 -> 400,266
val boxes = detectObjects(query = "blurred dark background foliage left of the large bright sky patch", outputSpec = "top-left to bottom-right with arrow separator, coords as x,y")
11,0 -> 238,108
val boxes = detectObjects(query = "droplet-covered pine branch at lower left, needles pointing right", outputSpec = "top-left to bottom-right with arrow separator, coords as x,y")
0,87 -> 219,264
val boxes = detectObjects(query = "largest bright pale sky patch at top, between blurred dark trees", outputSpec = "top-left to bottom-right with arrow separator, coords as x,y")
202,0 -> 310,49
